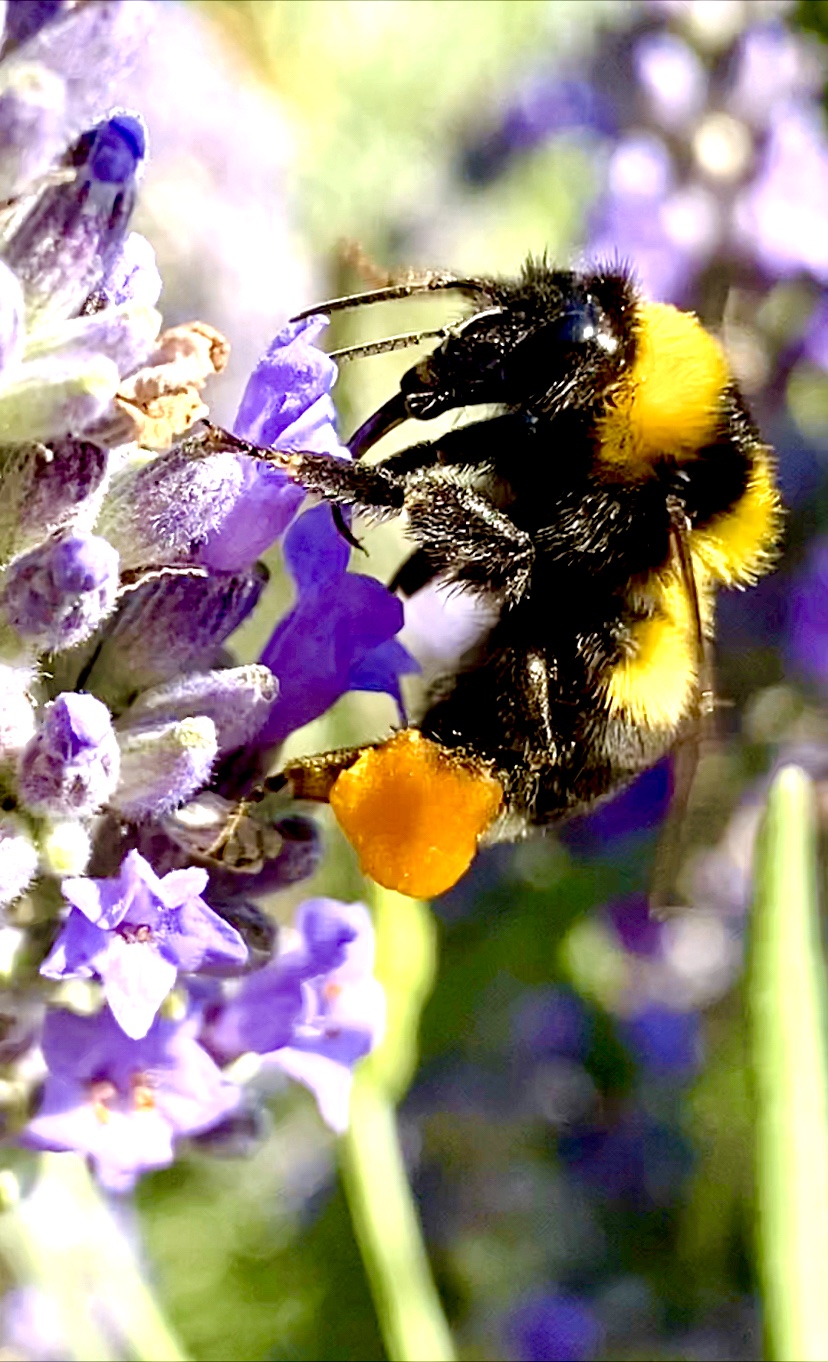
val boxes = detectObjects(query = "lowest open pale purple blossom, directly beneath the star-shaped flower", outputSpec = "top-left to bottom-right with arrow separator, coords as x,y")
23,1008 -> 240,1192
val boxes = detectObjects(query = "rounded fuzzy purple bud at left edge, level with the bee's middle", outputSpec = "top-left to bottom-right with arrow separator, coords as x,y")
0,534 -> 118,652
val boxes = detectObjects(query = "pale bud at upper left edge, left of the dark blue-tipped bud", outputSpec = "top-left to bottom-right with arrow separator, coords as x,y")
0,61 -> 65,203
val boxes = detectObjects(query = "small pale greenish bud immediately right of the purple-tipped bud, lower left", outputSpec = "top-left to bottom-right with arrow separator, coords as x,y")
110,716 -> 218,820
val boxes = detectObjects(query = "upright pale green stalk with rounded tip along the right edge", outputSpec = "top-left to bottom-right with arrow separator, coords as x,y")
748,767 -> 828,1362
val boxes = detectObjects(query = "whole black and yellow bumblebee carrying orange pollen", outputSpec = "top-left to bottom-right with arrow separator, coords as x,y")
238,259 -> 780,895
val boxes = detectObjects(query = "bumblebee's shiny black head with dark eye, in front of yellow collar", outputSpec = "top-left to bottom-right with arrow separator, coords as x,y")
400,263 -> 635,421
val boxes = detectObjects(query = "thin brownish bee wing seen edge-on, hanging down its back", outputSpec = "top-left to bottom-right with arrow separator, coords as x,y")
650,507 -> 716,917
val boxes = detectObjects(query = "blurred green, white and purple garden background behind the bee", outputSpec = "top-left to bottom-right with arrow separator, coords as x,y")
53,0 -> 828,1362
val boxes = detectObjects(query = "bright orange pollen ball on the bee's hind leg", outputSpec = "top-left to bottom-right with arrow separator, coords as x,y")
330,729 -> 503,899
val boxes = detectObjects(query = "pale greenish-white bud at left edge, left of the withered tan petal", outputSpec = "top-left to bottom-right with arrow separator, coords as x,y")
0,355 -> 120,444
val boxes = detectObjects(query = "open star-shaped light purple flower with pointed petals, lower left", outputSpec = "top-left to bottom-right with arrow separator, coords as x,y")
41,851 -> 248,1039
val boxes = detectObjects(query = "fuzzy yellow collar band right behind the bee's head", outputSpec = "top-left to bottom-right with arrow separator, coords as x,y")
599,302 -> 730,477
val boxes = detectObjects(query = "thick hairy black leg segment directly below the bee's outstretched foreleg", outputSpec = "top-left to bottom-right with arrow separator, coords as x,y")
404,469 -> 535,602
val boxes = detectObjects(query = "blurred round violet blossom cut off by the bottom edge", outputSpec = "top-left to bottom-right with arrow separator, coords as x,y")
504,1293 -> 603,1362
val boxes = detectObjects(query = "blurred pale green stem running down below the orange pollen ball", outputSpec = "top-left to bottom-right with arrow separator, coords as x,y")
342,889 -> 455,1362
